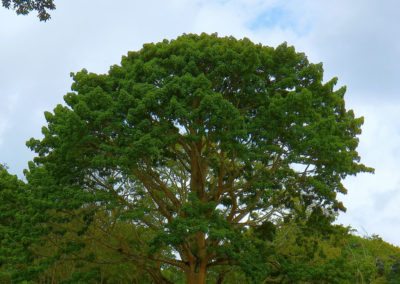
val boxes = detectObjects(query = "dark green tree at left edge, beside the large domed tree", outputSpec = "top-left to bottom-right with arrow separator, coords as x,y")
0,165 -> 44,283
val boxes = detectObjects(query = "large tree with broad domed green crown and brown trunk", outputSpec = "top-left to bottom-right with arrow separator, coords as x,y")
28,34 -> 371,283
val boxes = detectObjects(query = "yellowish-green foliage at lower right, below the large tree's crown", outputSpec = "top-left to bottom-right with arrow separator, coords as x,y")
267,223 -> 400,283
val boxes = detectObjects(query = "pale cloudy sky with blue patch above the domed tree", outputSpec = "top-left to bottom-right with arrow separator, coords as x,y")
0,0 -> 400,245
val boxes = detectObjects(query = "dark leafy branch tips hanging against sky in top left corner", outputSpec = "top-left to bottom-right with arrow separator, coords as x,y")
1,0 -> 56,21
